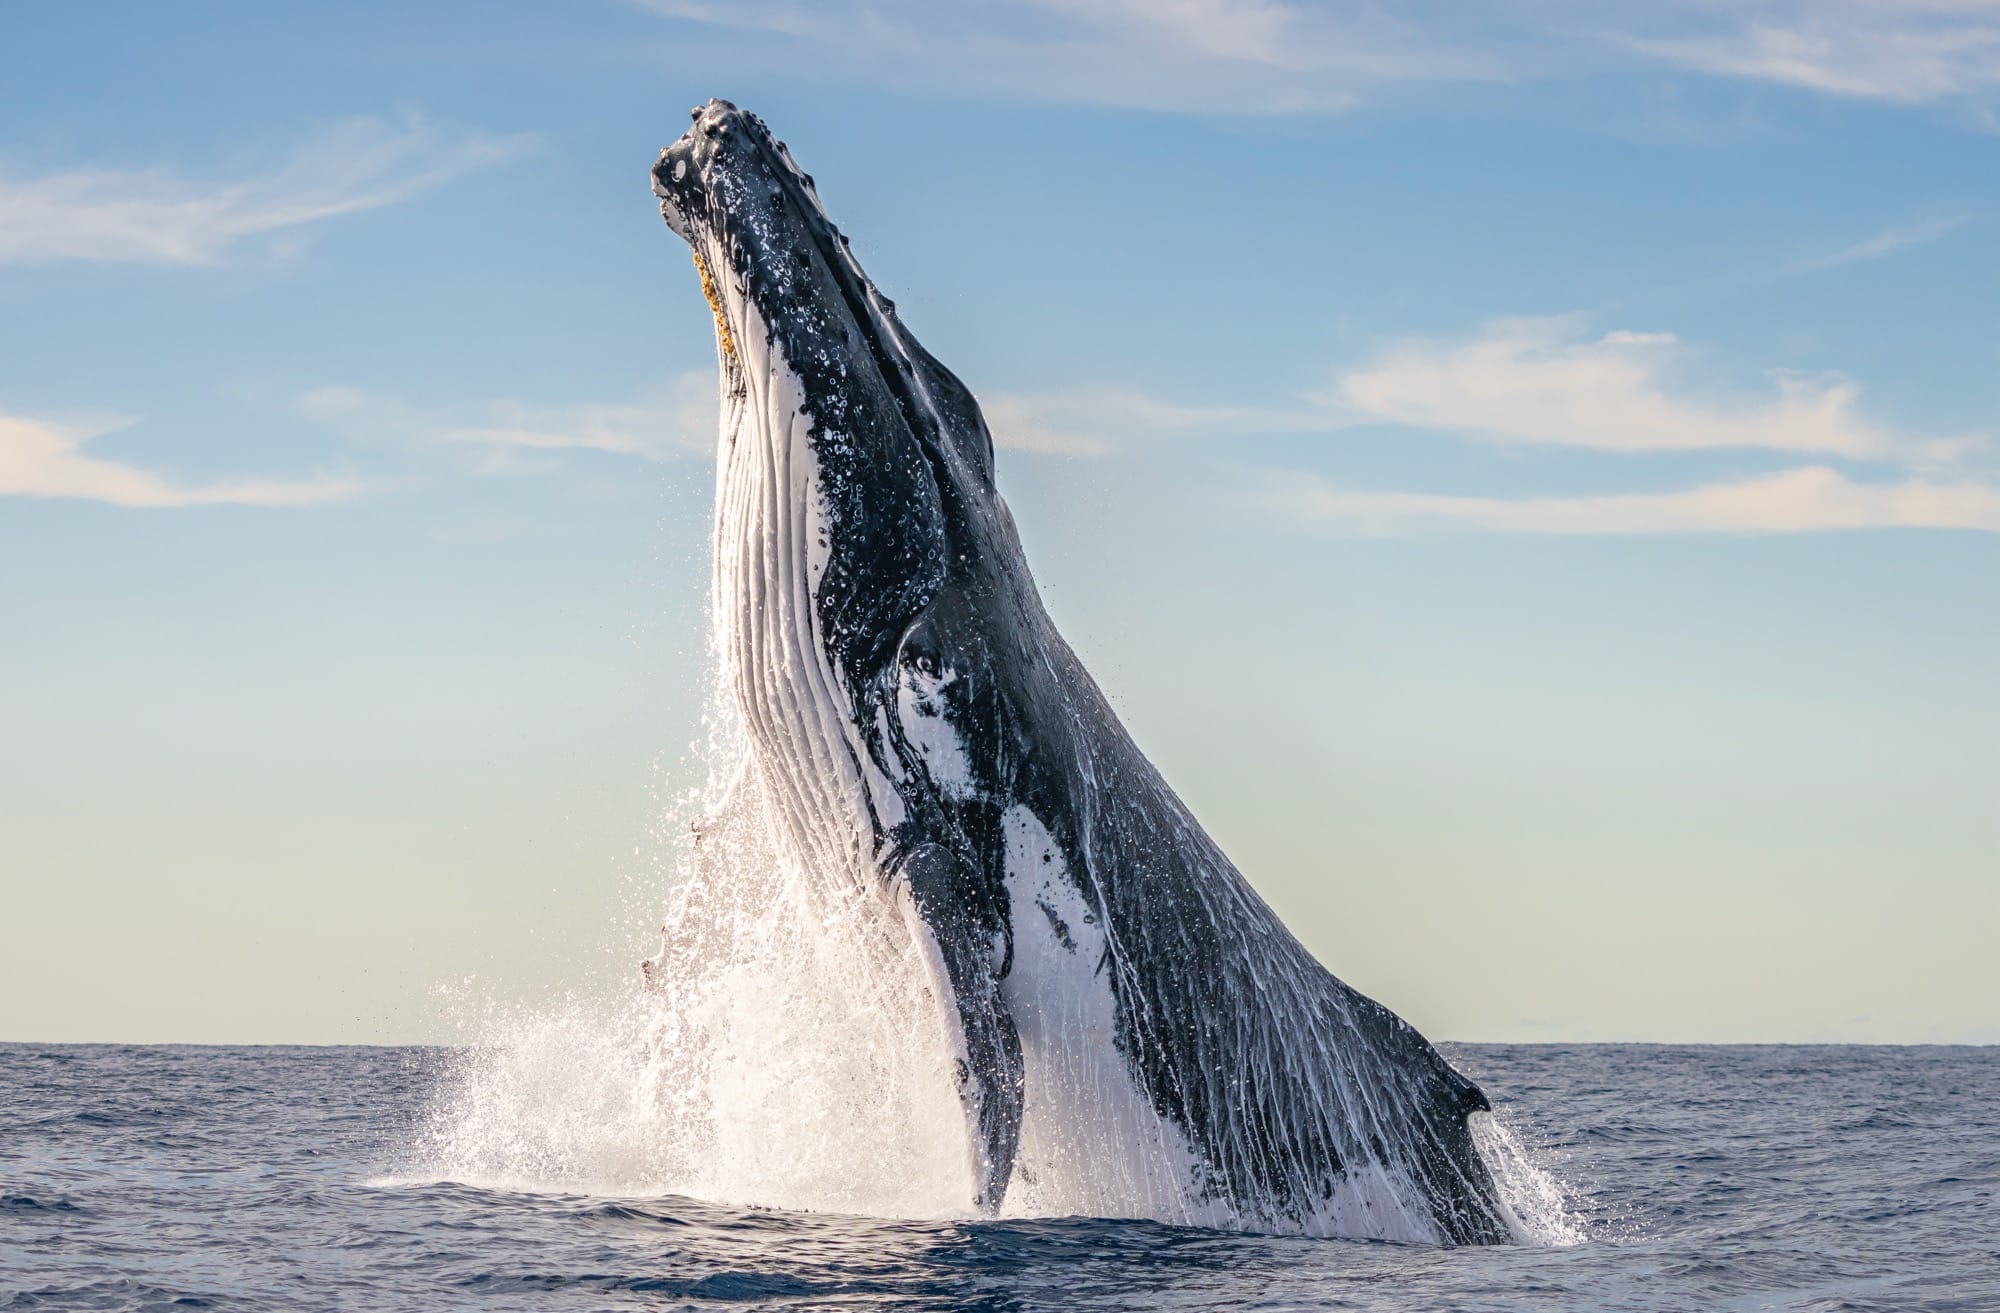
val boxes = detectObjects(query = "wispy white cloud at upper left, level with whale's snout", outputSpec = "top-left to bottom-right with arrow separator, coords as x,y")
0,118 -> 530,264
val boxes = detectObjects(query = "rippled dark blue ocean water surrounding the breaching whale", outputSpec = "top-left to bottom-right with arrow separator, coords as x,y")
0,1045 -> 2000,1311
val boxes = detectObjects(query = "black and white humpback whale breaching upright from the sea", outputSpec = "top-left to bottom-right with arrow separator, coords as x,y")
652,100 -> 1510,1245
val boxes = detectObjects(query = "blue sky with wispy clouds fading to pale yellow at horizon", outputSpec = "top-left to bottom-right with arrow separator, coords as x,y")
0,0 -> 2000,1043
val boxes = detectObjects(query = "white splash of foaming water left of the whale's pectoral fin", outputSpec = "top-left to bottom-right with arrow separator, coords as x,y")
416,708 -> 972,1217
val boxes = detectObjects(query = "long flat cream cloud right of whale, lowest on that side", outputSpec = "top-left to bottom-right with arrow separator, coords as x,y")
1254,466 -> 2000,536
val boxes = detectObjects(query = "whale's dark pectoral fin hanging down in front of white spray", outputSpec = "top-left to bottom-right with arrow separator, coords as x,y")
902,845 -> 1026,1213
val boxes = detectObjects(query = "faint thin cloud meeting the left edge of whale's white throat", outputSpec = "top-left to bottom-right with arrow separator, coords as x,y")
298,370 -> 716,474
